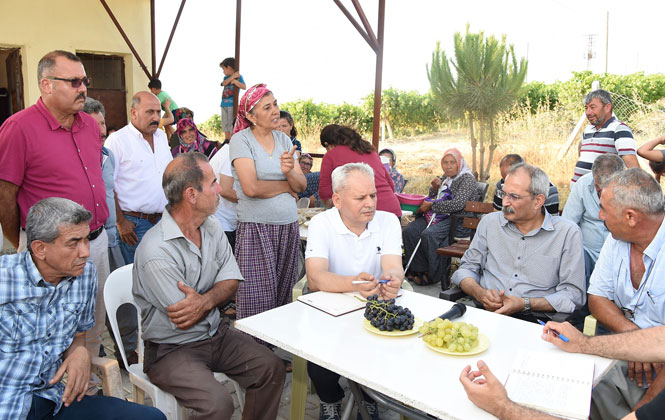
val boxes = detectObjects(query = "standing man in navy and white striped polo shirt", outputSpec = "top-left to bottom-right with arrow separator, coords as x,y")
571,89 -> 639,186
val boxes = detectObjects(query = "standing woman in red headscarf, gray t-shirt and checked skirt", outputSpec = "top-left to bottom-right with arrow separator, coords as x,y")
229,84 -> 307,319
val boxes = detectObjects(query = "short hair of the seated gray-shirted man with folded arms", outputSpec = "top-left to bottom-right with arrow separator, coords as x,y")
162,152 -> 208,211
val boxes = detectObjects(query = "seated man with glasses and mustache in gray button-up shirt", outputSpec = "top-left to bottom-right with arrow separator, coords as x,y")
451,163 -> 586,321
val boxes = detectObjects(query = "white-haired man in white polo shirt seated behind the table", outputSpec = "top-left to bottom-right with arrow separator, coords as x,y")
305,163 -> 404,420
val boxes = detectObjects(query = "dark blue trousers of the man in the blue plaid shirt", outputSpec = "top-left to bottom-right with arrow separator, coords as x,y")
27,395 -> 166,420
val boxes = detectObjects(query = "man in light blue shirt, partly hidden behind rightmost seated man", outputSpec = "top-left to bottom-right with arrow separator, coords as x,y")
561,154 -> 626,280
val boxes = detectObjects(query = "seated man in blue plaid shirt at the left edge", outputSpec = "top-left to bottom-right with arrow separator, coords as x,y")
0,198 -> 166,420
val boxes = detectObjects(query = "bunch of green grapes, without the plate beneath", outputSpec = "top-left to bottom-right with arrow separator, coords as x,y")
418,318 -> 478,353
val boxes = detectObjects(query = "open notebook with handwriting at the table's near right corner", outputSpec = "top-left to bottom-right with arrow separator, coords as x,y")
506,350 -> 594,419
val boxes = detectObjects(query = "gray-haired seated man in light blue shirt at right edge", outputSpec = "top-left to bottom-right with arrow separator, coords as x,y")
578,167 -> 665,419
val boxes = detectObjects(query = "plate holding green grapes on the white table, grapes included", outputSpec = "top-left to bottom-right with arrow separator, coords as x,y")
419,318 -> 490,356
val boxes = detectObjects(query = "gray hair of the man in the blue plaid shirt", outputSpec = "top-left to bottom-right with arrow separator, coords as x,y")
25,197 -> 92,252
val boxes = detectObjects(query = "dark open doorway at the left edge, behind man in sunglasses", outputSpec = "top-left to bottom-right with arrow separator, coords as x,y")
0,48 -> 25,125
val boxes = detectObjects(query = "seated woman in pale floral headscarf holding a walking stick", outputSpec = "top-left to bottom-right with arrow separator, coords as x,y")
402,149 -> 478,289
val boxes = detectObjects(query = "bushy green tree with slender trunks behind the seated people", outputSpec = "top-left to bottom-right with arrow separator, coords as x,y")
427,25 -> 527,181
